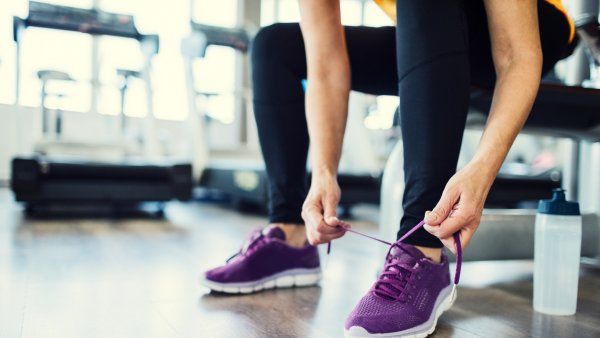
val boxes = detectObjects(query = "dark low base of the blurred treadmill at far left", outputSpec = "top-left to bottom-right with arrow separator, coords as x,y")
11,157 -> 192,216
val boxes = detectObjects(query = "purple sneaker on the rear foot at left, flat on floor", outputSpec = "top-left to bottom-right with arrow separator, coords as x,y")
201,226 -> 321,293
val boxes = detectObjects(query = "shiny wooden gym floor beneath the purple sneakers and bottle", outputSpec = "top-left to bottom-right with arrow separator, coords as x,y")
0,190 -> 600,338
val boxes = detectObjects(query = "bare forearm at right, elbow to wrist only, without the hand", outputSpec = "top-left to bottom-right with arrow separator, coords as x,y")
472,53 -> 541,184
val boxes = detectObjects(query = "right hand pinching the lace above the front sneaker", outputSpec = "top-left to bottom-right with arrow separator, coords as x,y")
424,163 -> 495,254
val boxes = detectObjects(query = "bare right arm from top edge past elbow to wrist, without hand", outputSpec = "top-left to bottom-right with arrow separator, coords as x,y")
472,0 -> 542,184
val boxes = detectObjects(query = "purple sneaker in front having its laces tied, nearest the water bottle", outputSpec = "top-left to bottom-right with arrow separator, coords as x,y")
344,241 -> 456,337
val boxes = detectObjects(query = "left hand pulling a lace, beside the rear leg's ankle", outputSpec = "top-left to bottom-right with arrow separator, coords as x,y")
302,173 -> 346,245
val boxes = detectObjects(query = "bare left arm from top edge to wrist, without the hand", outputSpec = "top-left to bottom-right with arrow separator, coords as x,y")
300,0 -> 350,177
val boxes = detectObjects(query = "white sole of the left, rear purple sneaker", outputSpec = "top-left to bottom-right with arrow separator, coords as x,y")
200,268 -> 322,294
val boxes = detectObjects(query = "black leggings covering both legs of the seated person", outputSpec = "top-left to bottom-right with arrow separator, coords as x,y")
252,0 -> 570,247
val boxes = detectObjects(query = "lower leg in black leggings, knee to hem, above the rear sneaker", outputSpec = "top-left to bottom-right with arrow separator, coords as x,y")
252,24 -> 308,224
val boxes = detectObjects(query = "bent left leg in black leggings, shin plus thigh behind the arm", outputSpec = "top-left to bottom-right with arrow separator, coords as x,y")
252,23 -> 397,224
